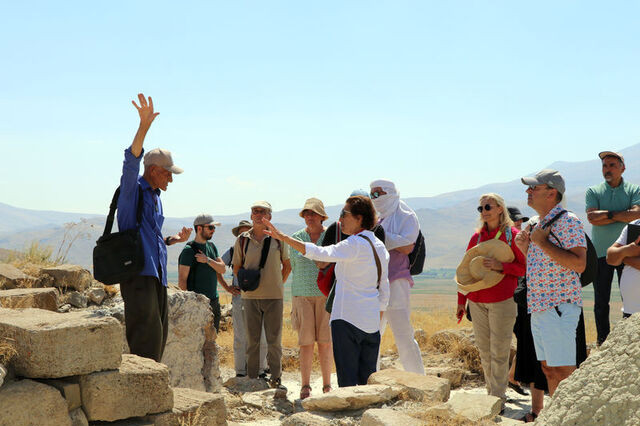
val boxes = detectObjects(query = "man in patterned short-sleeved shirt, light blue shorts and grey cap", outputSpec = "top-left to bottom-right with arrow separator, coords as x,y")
514,169 -> 587,396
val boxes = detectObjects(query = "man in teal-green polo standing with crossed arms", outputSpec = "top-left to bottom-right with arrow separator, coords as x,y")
585,151 -> 640,345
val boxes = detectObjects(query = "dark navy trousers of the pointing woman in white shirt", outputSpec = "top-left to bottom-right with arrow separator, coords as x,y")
331,320 -> 380,387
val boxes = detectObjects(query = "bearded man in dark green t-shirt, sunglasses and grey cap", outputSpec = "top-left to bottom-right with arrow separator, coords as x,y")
178,214 -> 237,331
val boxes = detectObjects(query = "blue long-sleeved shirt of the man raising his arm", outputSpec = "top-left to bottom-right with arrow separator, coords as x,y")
118,148 -> 167,287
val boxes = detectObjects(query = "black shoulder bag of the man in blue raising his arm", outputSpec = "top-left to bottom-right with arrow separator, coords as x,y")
93,187 -> 144,284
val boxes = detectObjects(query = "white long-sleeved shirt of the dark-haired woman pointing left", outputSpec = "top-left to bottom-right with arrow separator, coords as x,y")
305,231 -> 389,333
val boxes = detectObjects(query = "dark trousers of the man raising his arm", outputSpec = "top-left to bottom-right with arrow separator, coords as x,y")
120,275 -> 169,362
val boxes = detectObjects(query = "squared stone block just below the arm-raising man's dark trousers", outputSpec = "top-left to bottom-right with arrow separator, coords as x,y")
80,354 -> 173,421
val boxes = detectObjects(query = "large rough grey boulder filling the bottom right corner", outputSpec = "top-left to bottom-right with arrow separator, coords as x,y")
536,314 -> 640,426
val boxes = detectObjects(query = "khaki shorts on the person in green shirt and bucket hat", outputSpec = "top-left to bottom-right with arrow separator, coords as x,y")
291,296 -> 331,346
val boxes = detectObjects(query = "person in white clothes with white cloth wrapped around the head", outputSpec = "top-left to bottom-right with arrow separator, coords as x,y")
370,179 -> 424,374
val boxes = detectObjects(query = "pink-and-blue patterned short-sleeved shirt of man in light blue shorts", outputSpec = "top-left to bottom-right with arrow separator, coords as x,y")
527,204 -> 587,313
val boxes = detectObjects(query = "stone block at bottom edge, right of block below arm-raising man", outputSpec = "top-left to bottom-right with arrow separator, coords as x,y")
145,388 -> 227,426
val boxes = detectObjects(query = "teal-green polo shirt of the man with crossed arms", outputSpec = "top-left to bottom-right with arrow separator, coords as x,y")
585,179 -> 640,257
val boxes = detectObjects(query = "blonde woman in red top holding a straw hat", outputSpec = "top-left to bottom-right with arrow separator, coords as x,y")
456,193 -> 525,405
